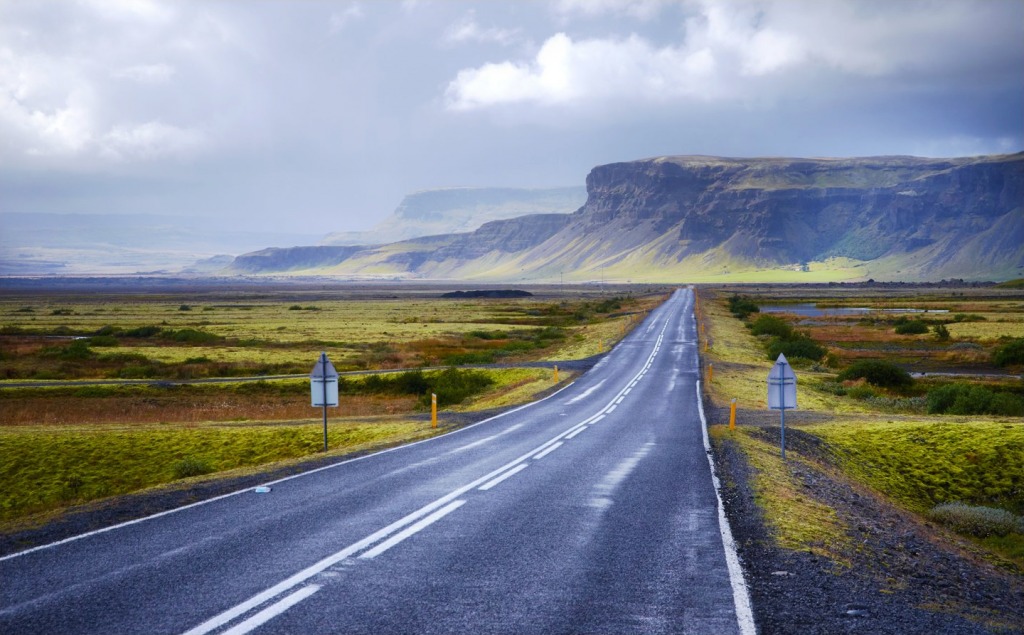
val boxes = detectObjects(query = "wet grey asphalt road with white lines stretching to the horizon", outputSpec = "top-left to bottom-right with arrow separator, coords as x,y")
0,290 -> 753,635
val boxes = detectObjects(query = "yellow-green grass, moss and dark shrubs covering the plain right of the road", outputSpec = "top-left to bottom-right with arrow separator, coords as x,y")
700,290 -> 1024,572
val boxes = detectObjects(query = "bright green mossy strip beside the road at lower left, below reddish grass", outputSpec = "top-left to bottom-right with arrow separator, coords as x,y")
0,420 -> 433,526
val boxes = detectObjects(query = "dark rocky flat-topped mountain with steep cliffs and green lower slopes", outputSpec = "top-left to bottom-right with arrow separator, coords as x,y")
231,153 -> 1024,282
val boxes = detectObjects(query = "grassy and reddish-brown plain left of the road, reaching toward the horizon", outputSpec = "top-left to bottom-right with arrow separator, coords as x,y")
0,290 -> 657,530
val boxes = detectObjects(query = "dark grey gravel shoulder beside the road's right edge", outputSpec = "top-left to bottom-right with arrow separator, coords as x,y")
713,425 -> 1024,635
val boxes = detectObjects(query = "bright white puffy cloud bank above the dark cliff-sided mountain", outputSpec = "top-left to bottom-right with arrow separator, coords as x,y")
445,0 -> 1024,112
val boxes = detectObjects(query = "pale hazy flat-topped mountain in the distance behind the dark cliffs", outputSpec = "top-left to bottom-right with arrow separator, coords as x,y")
321,186 -> 587,246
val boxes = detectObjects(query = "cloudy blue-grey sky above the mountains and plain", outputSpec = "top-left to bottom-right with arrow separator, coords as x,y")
0,0 -> 1024,234
